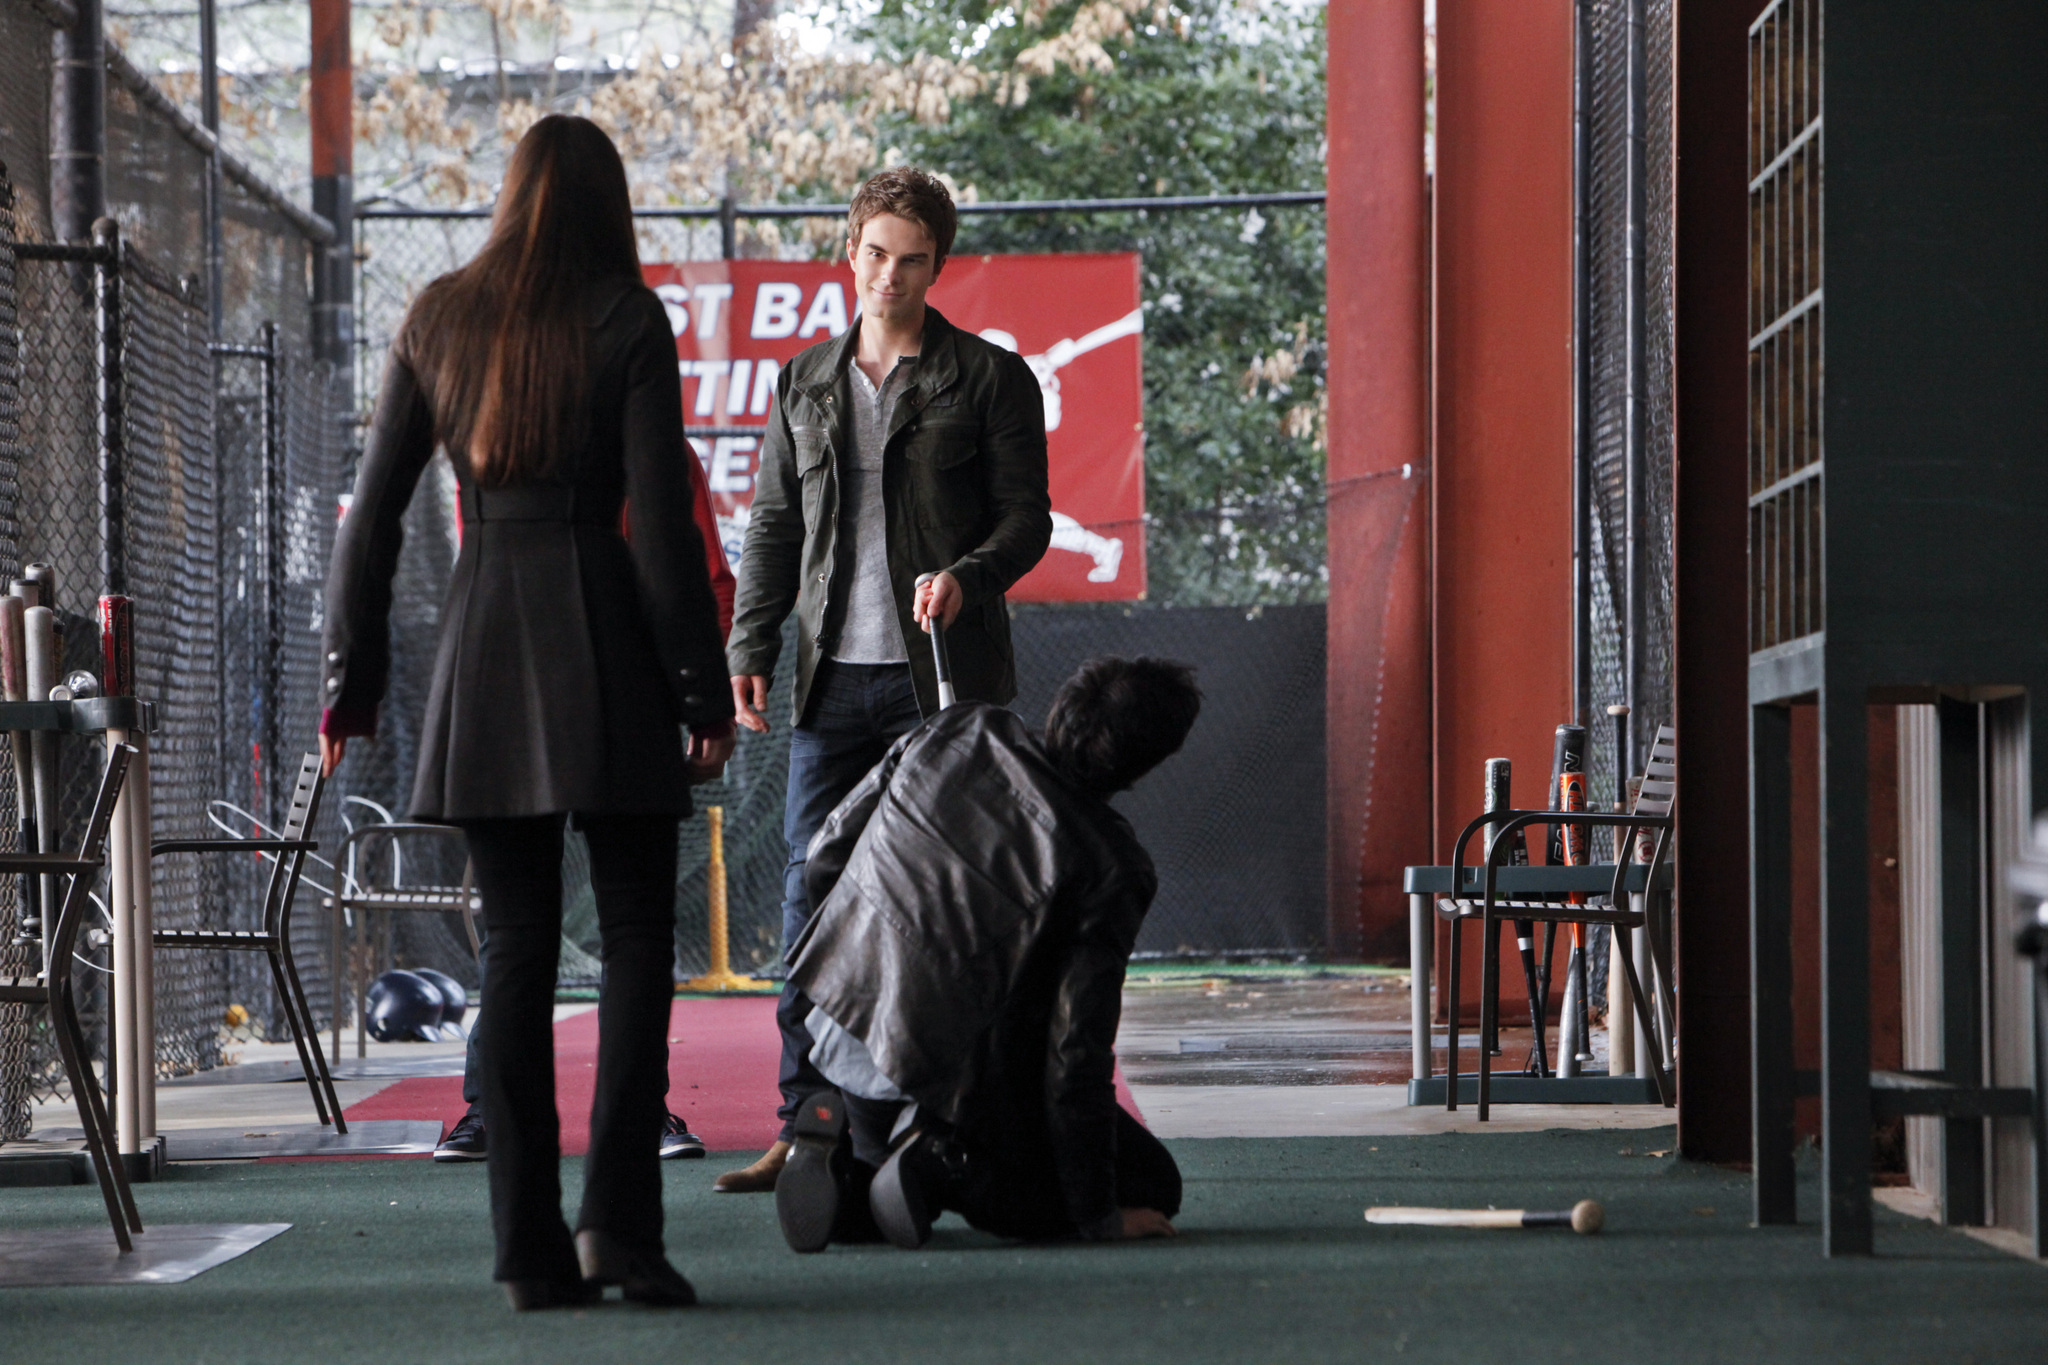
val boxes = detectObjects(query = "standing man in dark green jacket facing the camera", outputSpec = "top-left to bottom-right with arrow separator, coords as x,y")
717,166 -> 1053,1193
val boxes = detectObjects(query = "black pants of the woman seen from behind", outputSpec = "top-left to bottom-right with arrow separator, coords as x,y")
463,814 -> 676,1281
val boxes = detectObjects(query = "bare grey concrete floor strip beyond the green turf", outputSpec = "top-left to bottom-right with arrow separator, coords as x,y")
35,974 -> 1671,1138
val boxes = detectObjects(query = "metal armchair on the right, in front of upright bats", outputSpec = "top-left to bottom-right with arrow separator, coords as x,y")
1436,724 -> 1677,1121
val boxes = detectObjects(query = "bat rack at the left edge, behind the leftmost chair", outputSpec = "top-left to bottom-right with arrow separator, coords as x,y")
0,696 -> 164,1181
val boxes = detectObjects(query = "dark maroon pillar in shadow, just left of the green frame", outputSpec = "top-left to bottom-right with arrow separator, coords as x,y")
1673,0 -> 1761,1162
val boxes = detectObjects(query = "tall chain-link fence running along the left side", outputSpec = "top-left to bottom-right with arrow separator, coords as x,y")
0,26 -> 348,1138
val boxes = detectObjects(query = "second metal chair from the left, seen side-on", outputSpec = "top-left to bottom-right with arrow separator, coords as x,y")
150,753 -> 348,1134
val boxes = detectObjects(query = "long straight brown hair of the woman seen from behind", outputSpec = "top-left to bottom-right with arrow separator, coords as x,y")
406,115 -> 639,485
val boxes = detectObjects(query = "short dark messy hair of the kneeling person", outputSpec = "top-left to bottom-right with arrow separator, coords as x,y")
1044,657 -> 1202,796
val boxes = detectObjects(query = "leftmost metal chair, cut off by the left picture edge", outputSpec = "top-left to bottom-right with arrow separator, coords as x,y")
0,745 -> 141,1250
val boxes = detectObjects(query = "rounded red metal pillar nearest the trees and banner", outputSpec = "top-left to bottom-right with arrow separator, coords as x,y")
1327,0 -> 1432,962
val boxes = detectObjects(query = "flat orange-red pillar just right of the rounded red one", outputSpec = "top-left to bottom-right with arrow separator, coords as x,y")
1432,0 -> 1573,1019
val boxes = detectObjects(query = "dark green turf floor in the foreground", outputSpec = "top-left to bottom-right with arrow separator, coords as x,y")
0,1130 -> 2048,1365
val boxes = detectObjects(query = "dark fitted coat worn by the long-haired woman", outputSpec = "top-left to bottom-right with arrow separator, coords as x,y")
326,280 -> 733,821
